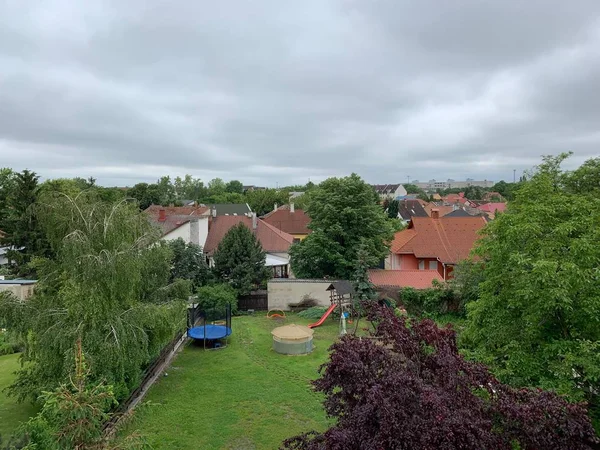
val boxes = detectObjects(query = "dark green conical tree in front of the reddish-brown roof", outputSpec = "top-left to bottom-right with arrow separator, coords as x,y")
213,223 -> 270,295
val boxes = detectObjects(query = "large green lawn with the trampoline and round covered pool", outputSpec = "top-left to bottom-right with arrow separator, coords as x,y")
121,313 -> 338,450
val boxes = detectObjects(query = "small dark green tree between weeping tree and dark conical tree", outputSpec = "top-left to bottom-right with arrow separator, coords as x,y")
169,238 -> 211,289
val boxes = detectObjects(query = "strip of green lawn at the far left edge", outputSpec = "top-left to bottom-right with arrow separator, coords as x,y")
0,354 -> 37,437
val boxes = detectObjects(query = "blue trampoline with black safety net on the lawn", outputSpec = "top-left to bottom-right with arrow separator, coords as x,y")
187,304 -> 232,349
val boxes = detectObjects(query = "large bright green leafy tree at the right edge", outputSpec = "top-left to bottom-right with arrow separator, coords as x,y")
463,154 -> 600,417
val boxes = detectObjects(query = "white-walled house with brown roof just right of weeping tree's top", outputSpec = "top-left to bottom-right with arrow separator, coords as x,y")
144,205 -> 211,247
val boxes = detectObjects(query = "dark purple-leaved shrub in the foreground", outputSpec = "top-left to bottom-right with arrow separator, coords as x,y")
283,308 -> 599,450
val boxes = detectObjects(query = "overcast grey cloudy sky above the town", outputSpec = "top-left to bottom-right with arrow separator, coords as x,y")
0,0 -> 600,186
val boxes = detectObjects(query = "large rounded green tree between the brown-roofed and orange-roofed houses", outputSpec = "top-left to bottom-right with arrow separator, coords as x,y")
290,174 -> 394,279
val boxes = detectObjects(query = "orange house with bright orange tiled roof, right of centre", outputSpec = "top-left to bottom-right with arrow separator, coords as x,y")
385,209 -> 487,280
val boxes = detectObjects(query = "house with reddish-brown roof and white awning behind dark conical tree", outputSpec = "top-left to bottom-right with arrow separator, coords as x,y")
204,213 -> 294,278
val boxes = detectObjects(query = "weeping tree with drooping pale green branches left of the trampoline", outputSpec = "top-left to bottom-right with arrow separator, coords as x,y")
0,193 -> 189,399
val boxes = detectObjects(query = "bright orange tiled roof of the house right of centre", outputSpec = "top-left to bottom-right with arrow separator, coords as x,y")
391,217 -> 487,264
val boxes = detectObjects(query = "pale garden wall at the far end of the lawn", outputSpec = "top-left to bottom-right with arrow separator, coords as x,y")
267,278 -> 335,311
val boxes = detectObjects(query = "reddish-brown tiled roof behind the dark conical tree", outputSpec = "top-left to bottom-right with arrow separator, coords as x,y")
204,216 -> 294,253
